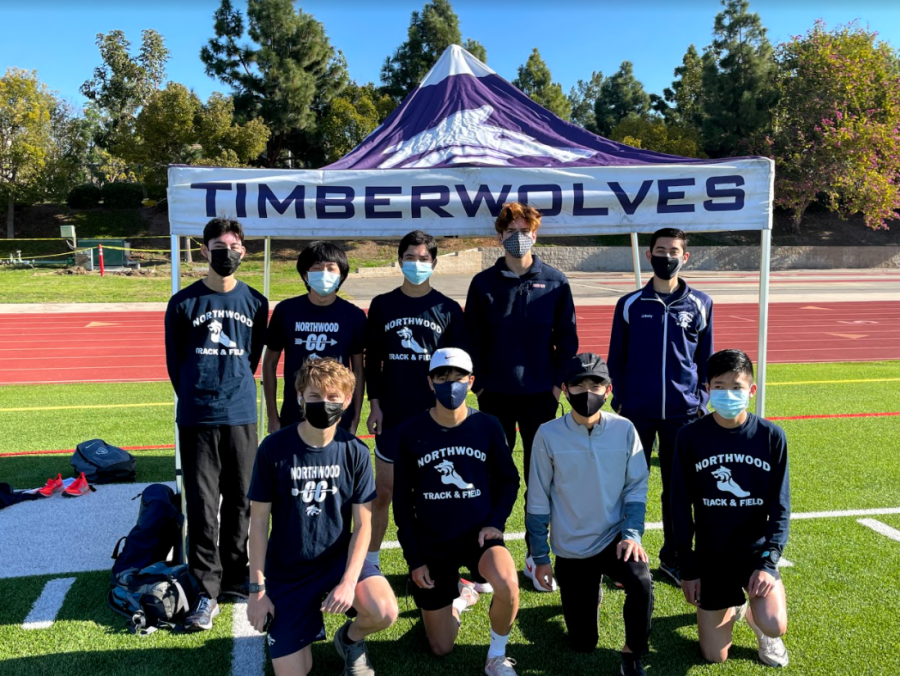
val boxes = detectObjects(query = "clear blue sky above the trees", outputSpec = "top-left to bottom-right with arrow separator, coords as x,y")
0,0 -> 900,113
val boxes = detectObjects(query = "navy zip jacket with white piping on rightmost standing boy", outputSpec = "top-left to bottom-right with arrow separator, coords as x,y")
607,280 -> 713,419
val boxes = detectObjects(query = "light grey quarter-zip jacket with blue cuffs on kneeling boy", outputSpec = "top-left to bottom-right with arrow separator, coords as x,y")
525,411 -> 650,564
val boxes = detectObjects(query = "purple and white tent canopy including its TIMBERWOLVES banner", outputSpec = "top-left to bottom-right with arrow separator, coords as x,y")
169,45 -> 774,238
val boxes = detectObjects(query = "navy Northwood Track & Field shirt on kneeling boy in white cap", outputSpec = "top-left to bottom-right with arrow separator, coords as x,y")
394,408 -> 519,570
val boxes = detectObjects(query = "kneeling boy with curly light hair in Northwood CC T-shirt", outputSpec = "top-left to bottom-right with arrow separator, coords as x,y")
248,358 -> 398,676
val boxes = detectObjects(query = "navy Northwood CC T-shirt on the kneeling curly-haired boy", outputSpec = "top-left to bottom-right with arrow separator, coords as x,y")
247,424 -> 375,581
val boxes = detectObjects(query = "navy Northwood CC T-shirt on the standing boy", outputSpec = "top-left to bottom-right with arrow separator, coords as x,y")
266,295 -> 366,424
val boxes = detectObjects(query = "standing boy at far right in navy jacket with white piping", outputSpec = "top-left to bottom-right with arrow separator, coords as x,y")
607,228 -> 713,584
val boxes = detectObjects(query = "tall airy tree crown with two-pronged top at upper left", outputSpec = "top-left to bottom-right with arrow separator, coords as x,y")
81,30 -> 169,139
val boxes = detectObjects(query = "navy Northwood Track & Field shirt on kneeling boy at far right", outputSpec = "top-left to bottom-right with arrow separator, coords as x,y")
670,413 -> 791,580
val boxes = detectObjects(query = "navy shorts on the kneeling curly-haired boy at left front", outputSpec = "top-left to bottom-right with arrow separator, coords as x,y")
266,557 -> 381,660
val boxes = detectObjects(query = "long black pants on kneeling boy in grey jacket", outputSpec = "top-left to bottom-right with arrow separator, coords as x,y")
556,538 -> 653,655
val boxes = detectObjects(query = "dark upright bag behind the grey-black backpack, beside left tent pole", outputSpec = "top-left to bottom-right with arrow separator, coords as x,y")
110,484 -> 184,586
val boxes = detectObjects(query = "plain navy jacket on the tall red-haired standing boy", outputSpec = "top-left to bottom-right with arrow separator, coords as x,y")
465,256 -> 578,394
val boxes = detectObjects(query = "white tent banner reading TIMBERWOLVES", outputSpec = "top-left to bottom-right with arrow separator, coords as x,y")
168,158 -> 774,238
